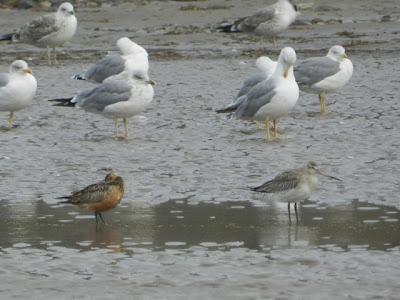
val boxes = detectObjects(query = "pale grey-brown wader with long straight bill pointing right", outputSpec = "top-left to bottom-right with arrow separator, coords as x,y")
251,161 -> 342,220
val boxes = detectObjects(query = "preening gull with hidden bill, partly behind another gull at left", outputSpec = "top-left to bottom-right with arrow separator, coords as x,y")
72,37 -> 149,83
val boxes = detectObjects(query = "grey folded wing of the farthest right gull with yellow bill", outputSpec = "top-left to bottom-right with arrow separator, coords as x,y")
294,56 -> 340,86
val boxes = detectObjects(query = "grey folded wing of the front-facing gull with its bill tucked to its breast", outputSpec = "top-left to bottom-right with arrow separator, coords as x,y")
235,80 -> 276,120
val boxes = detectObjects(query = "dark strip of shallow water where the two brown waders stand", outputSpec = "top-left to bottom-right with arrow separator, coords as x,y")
0,201 -> 400,252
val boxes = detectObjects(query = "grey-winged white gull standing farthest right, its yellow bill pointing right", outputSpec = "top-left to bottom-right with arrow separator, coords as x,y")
294,45 -> 353,114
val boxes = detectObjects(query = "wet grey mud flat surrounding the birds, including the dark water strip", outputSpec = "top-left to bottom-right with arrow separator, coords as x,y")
0,1 -> 400,299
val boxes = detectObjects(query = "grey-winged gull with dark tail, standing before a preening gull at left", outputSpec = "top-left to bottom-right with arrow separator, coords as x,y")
49,68 -> 155,139
